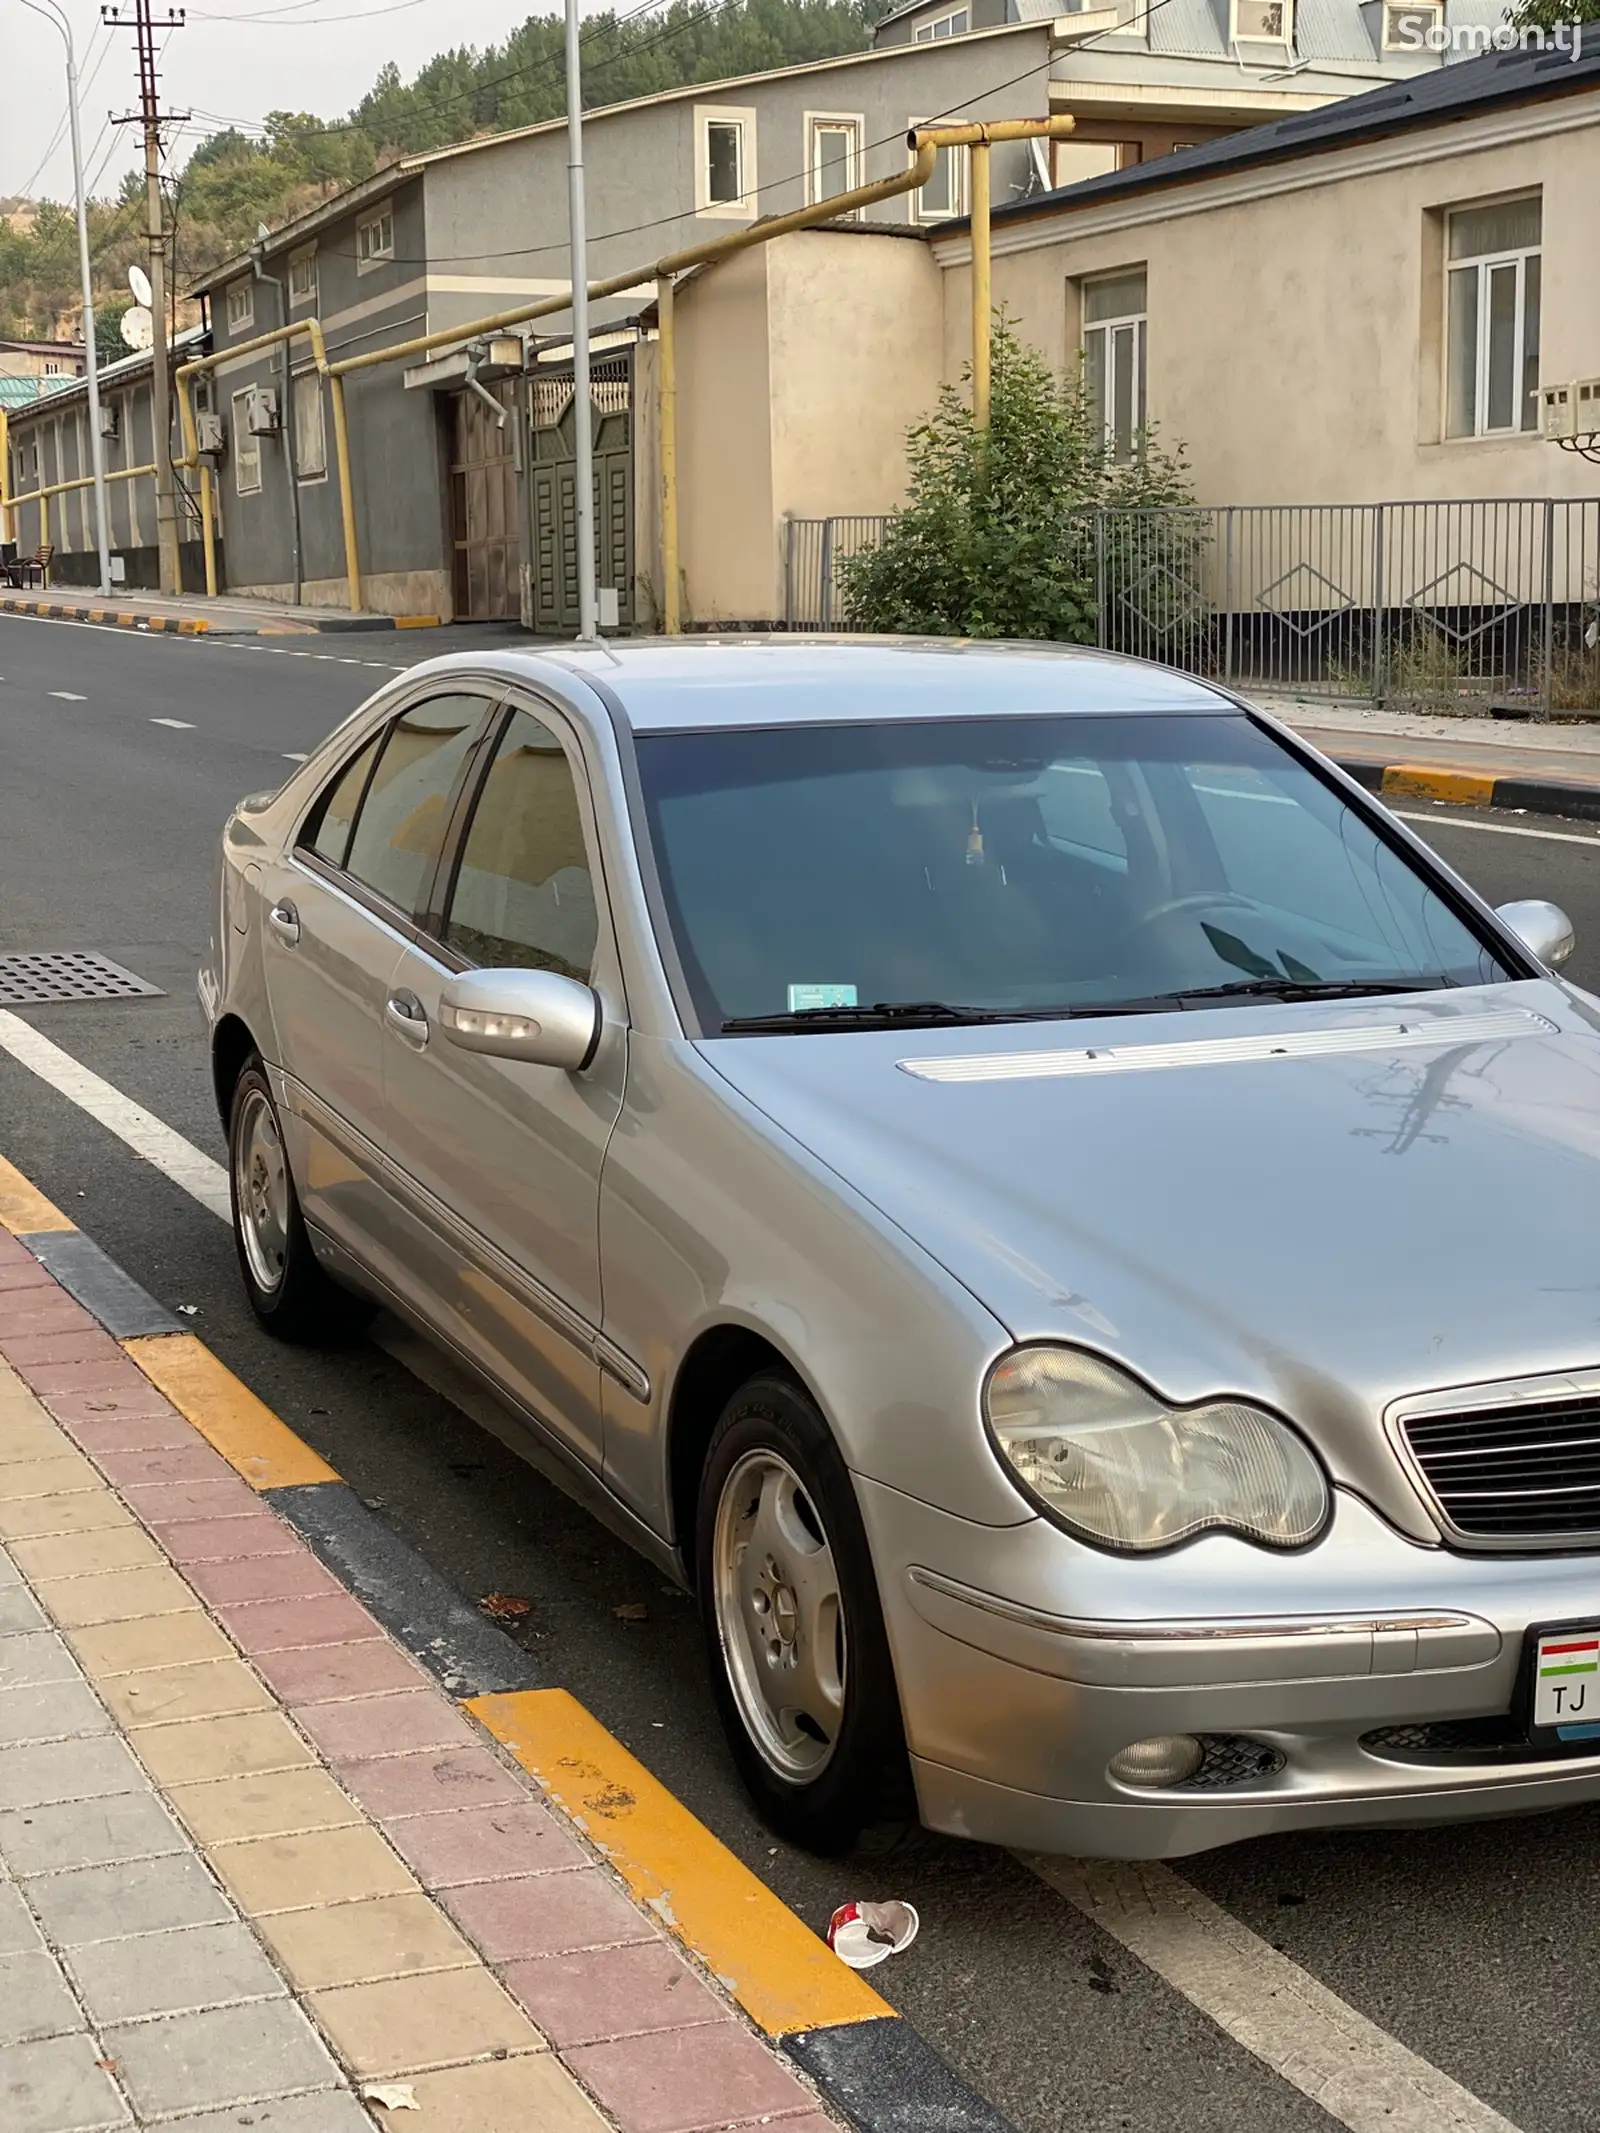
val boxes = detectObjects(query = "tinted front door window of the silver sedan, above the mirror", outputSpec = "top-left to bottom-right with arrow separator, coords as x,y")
444,710 -> 595,979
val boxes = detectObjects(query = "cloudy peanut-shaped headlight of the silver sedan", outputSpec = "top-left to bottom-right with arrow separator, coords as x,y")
983,1346 -> 1327,1553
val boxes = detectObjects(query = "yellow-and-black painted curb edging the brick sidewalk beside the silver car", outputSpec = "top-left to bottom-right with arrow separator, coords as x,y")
0,1156 -> 1013,2133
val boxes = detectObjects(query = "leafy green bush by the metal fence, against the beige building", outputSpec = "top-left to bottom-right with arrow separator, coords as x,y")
838,314 -> 1193,644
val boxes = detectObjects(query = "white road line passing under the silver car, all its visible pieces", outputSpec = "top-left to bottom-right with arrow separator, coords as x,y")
0,1009 -> 1544,2133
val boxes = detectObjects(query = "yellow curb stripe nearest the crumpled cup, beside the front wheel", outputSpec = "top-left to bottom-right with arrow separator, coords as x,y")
465,1689 -> 894,2037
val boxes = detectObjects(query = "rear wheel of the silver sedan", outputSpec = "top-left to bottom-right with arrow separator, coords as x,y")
228,1052 -> 365,1342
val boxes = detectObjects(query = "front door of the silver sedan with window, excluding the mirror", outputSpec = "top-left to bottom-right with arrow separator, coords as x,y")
384,710 -> 627,1468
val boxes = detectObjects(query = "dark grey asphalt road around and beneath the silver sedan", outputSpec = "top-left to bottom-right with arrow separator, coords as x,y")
0,619 -> 1600,2133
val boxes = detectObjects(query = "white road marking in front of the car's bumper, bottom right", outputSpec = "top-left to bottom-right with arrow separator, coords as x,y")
1024,1858 -> 1517,2133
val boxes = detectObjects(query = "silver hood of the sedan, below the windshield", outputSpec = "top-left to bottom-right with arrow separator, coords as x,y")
702,979 -> 1600,1538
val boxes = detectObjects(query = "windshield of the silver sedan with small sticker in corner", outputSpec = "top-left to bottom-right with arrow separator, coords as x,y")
638,715 -> 1510,1032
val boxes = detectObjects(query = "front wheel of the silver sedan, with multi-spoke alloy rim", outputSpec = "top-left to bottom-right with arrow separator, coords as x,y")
695,1374 -> 915,1854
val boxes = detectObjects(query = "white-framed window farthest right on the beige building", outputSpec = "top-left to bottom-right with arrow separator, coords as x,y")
1444,198 -> 1540,437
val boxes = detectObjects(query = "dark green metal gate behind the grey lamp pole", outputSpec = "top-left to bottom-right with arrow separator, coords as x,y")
523,352 -> 634,636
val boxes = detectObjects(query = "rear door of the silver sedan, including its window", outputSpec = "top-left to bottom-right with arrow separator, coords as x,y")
262,691 -> 493,1261
